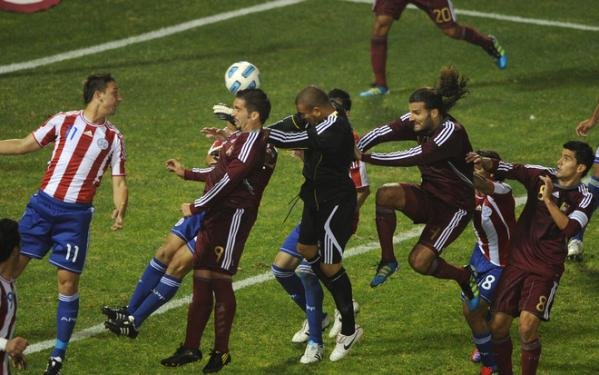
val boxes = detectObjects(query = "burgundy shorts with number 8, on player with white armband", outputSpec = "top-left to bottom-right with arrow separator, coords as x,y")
491,265 -> 559,320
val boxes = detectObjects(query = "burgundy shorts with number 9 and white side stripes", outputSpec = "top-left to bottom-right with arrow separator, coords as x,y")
194,208 -> 256,275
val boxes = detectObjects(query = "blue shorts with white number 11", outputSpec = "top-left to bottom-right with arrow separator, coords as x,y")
19,191 -> 94,273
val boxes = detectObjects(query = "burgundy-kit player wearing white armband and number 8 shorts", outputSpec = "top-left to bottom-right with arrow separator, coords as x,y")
468,141 -> 595,375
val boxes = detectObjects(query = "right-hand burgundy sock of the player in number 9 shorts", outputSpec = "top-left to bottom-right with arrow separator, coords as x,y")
212,279 -> 237,353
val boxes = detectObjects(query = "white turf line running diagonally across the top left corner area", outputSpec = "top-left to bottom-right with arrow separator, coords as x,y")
0,0 -> 306,75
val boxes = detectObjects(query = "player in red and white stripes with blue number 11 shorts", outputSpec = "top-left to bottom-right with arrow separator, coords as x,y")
0,74 -> 128,374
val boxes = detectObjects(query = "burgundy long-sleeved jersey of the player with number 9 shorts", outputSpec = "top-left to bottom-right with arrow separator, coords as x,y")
185,129 -> 277,213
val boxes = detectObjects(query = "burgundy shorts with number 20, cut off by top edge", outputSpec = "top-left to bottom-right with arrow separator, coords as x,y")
372,0 -> 456,29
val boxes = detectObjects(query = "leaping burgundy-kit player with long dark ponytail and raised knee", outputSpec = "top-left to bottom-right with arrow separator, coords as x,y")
357,67 -> 478,310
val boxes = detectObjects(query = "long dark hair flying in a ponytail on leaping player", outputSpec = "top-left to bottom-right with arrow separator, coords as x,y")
408,66 -> 468,115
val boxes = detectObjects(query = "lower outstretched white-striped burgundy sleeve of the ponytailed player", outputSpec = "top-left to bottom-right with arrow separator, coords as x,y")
362,122 -> 463,167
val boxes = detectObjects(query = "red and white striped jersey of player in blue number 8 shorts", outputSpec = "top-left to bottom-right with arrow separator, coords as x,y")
472,181 -> 516,267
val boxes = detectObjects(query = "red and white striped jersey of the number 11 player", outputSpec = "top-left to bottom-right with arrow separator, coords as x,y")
33,111 -> 127,203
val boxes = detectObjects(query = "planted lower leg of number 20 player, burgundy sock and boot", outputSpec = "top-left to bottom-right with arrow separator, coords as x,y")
360,15 -> 394,97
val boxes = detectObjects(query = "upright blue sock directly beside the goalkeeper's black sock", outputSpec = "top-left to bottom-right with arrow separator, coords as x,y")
298,265 -> 324,344
